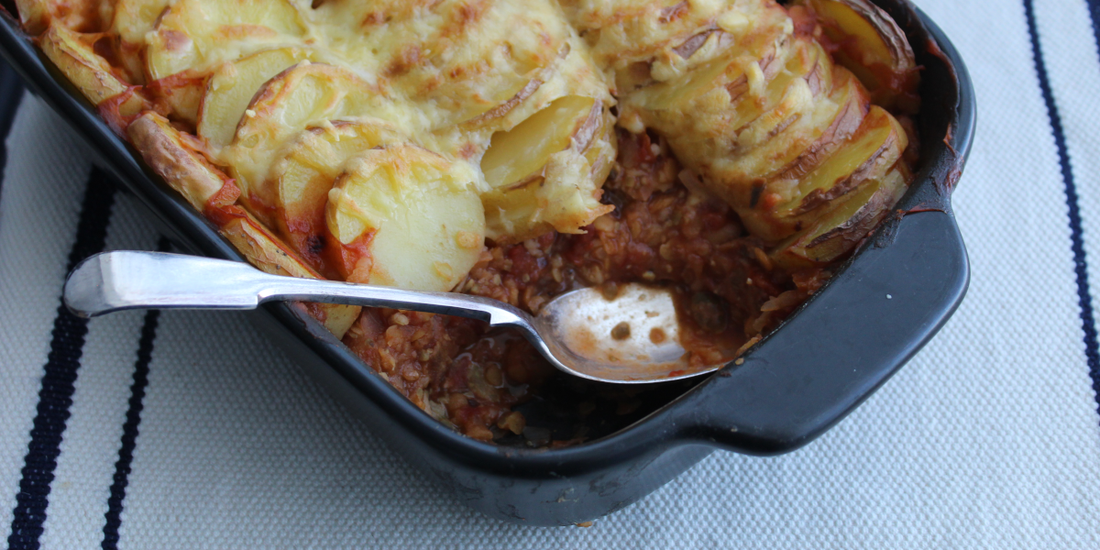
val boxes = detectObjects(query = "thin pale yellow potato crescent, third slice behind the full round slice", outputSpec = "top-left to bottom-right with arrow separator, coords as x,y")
196,47 -> 311,151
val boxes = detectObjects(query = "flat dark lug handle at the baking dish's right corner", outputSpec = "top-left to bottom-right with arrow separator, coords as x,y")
674,210 -> 970,454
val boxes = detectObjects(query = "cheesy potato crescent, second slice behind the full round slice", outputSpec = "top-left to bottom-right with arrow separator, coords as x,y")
218,62 -> 413,210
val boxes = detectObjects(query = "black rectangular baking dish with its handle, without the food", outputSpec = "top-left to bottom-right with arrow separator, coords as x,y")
0,0 -> 975,525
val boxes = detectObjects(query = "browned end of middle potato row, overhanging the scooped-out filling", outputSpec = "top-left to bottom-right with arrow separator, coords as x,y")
481,96 -> 614,242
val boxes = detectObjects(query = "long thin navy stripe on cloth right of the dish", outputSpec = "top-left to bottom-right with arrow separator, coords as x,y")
1024,0 -> 1100,409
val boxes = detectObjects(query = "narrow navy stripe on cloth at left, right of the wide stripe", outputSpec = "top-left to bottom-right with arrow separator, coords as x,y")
101,237 -> 169,550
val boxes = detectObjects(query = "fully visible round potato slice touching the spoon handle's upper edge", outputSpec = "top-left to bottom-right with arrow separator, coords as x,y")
326,144 -> 485,290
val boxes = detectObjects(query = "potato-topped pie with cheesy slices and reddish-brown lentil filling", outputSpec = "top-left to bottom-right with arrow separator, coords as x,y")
17,0 -> 919,444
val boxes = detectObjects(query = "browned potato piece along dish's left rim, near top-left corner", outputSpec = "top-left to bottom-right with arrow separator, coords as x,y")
39,24 -> 145,116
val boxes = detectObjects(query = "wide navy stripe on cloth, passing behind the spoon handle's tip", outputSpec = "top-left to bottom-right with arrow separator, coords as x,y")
8,168 -> 114,550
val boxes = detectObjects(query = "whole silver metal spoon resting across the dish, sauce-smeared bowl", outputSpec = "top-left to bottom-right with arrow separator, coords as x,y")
65,251 -> 722,384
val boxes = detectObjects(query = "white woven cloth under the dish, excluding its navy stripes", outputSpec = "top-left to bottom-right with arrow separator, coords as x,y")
0,0 -> 1100,549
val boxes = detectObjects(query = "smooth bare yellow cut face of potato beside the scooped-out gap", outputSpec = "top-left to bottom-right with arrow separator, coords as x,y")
481,96 -> 596,189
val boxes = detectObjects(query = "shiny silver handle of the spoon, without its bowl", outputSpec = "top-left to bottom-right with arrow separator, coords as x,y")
64,251 -> 530,330
